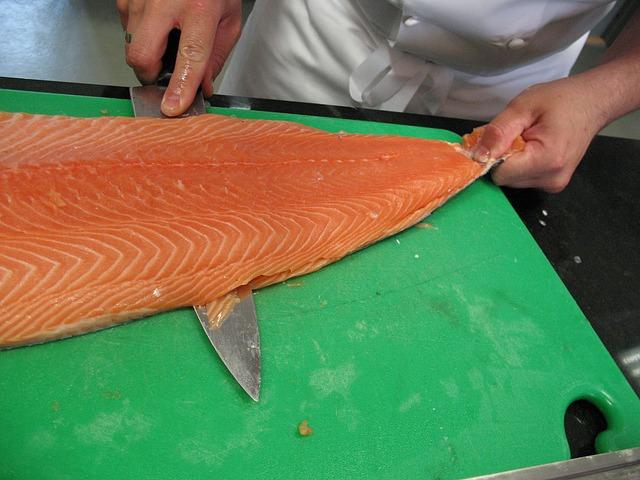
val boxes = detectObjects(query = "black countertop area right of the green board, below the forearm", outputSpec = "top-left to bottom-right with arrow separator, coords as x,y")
505,137 -> 640,376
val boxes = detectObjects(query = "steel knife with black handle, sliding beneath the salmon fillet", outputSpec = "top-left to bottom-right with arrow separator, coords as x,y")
130,30 -> 260,401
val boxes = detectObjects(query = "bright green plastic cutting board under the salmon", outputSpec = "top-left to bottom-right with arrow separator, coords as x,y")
0,91 -> 640,480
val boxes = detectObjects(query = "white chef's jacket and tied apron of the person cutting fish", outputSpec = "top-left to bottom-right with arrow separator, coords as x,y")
219,0 -> 615,119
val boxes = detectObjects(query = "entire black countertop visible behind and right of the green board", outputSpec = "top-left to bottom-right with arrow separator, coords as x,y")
0,77 -> 640,395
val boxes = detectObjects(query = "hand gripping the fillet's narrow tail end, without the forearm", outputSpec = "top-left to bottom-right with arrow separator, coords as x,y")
473,77 -> 607,192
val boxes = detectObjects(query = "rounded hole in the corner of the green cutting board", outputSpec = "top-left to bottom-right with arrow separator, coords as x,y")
564,400 -> 607,458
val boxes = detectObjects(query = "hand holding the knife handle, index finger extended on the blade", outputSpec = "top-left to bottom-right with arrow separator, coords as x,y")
117,0 -> 242,116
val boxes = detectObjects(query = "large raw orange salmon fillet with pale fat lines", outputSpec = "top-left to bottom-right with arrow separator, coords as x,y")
0,113 -> 500,347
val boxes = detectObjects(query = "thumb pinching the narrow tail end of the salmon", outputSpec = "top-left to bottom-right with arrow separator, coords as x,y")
472,104 -> 535,159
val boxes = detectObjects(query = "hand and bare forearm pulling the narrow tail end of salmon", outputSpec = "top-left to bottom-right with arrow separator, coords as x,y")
472,10 -> 640,192
